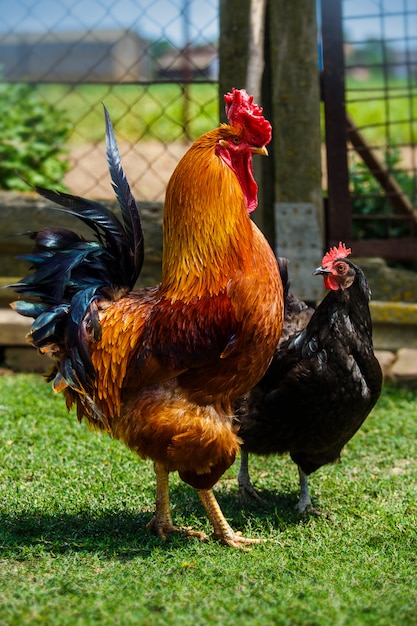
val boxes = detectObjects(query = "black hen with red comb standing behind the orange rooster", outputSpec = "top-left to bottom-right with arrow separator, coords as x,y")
236,244 -> 382,513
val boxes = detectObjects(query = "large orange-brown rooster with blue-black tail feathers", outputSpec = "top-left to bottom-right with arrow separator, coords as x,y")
12,89 -> 283,547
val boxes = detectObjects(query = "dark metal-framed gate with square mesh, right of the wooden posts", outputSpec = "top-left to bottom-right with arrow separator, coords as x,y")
321,0 -> 417,261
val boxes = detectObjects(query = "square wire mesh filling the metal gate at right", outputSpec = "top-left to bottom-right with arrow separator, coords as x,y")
342,0 -> 417,239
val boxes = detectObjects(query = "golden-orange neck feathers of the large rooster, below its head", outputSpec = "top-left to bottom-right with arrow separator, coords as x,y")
161,126 -> 253,301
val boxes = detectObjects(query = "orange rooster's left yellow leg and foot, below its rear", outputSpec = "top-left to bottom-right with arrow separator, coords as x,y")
147,462 -> 206,540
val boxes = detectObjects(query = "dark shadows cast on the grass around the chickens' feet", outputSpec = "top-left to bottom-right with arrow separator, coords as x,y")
0,486 -> 306,560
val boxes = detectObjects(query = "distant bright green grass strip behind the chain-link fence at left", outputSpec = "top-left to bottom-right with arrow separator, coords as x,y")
39,83 -> 219,145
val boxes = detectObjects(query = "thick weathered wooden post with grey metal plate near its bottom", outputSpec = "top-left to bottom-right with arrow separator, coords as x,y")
267,0 -> 324,301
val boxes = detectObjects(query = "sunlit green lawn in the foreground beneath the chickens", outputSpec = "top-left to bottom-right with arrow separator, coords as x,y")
0,374 -> 417,626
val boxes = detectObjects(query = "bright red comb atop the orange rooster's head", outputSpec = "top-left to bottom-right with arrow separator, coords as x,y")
224,88 -> 272,146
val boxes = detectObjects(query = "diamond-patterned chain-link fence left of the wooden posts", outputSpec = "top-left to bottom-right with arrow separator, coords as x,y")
0,0 -> 219,201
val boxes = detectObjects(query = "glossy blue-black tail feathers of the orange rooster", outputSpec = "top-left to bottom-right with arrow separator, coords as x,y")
10,108 -> 144,425
